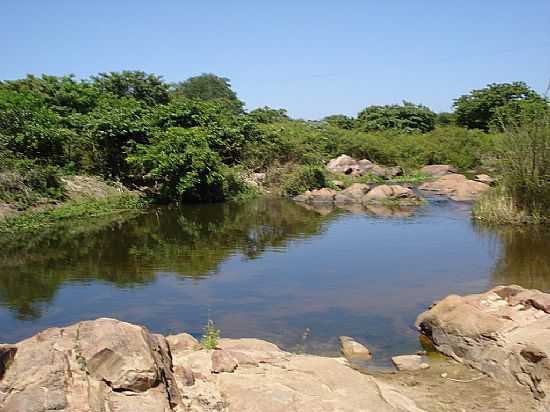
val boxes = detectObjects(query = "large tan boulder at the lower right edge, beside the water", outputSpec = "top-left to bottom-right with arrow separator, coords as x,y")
416,286 -> 550,410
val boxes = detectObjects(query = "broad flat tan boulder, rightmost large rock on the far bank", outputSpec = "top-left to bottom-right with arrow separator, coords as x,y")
419,174 -> 490,202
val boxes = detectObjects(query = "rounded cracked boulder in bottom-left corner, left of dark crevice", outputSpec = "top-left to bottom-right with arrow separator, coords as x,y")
0,319 -> 181,412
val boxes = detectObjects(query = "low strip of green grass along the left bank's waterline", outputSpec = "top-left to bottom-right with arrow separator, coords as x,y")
0,195 -> 148,234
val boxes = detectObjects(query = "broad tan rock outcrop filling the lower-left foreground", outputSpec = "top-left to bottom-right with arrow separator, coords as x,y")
0,319 -> 423,412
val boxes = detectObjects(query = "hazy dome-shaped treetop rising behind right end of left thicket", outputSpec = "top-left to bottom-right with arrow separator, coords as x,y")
173,73 -> 244,112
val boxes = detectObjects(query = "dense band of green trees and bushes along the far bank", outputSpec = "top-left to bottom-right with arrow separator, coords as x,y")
0,71 -> 549,227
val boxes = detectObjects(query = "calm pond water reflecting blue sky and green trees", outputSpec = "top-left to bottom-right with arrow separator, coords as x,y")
0,199 -> 550,364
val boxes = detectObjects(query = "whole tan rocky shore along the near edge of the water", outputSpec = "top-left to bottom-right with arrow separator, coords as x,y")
0,286 -> 550,412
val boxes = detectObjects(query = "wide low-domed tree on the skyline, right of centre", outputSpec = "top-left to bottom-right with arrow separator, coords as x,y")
357,102 -> 436,133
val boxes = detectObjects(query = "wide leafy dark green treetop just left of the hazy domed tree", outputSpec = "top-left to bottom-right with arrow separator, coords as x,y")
91,70 -> 169,105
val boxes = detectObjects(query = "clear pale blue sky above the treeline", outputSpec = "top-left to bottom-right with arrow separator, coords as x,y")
0,0 -> 550,119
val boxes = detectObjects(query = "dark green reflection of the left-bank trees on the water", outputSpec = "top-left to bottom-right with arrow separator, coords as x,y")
0,199 -> 334,319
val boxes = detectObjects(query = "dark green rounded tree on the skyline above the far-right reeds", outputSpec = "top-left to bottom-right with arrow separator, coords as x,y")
454,82 -> 547,131
